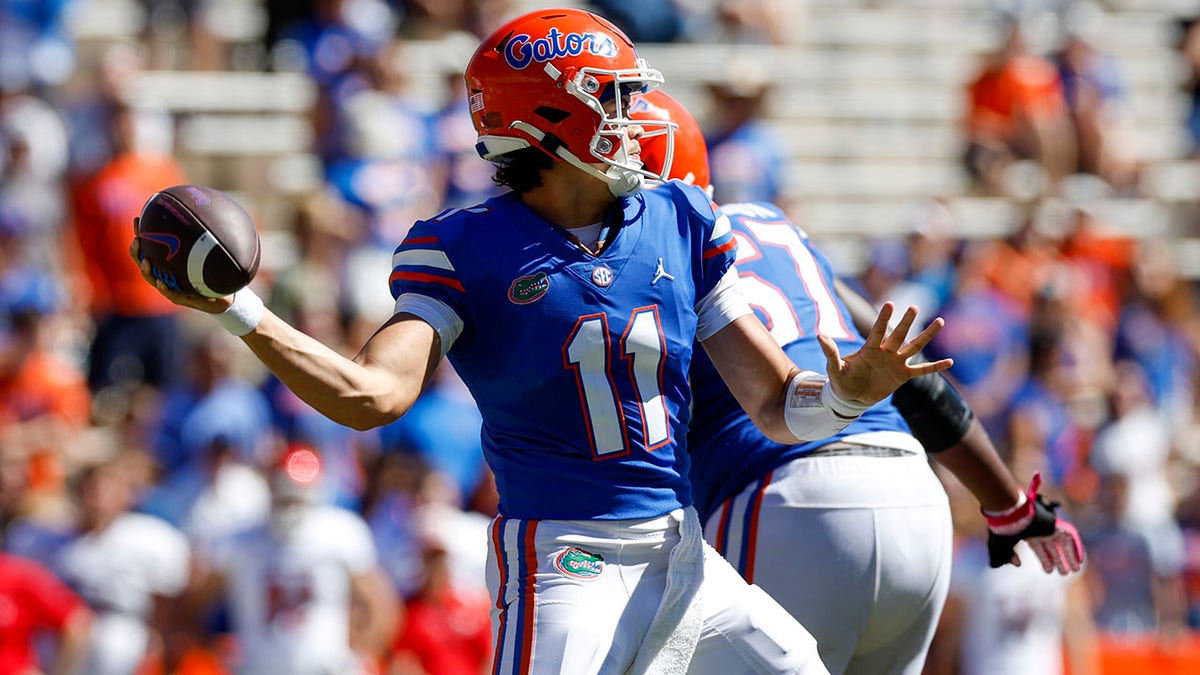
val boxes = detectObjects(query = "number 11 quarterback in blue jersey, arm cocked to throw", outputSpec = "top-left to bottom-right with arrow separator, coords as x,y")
131,10 -> 950,675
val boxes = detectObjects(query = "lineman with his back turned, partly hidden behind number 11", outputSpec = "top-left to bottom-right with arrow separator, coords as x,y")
630,90 -> 1082,675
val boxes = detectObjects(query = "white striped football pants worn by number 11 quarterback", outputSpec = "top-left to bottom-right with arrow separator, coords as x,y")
487,509 -> 828,675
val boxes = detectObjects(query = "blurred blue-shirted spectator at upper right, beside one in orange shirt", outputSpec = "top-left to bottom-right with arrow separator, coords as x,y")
1054,1 -> 1138,192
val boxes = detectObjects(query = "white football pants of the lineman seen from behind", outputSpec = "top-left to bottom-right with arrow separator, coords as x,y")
704,441 -> 952,675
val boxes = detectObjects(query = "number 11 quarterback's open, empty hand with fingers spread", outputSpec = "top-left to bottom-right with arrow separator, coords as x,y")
817,303 -> 954,405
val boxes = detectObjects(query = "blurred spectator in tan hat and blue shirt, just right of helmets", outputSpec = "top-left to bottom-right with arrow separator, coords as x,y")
704,58 -> 784,204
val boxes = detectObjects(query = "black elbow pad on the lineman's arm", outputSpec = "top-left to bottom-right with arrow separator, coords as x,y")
892,365 -> 974,453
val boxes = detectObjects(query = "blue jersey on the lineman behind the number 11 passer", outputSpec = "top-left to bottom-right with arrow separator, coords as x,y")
688,203 -> 910,520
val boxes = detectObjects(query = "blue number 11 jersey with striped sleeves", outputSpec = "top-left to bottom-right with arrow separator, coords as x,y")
391,184 -> 734,520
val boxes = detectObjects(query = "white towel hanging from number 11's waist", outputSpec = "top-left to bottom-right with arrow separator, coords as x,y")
629,507 -> 704,675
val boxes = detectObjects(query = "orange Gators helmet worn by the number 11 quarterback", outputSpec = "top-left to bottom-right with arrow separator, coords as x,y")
464,8 -> 671,196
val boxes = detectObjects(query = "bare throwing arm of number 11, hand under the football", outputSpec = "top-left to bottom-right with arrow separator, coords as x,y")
130,239 -> 442,430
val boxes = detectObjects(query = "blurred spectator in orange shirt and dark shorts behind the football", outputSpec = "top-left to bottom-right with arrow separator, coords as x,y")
71,102 -> 186,392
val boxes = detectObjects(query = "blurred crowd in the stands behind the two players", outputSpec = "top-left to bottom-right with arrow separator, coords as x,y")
0,0 -> 1200,675
